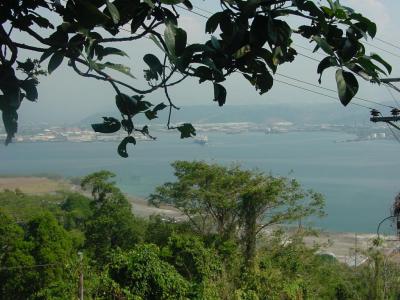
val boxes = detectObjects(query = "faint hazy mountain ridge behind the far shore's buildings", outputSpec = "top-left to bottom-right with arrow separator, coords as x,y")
78,103 -> 380,126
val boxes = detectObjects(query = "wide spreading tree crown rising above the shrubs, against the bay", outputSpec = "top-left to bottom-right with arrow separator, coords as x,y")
150,161 -> 324,268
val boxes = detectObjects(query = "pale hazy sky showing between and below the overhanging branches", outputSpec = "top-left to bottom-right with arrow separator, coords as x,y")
20,0 -> 400,122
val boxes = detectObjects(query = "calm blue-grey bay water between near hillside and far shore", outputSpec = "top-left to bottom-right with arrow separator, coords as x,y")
0,132 -> 400,233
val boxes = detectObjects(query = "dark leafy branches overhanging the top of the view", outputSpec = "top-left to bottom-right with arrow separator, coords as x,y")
0,0 -> 391,157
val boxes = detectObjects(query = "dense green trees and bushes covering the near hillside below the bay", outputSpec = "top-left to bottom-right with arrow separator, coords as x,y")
0,162 -> 400,299
